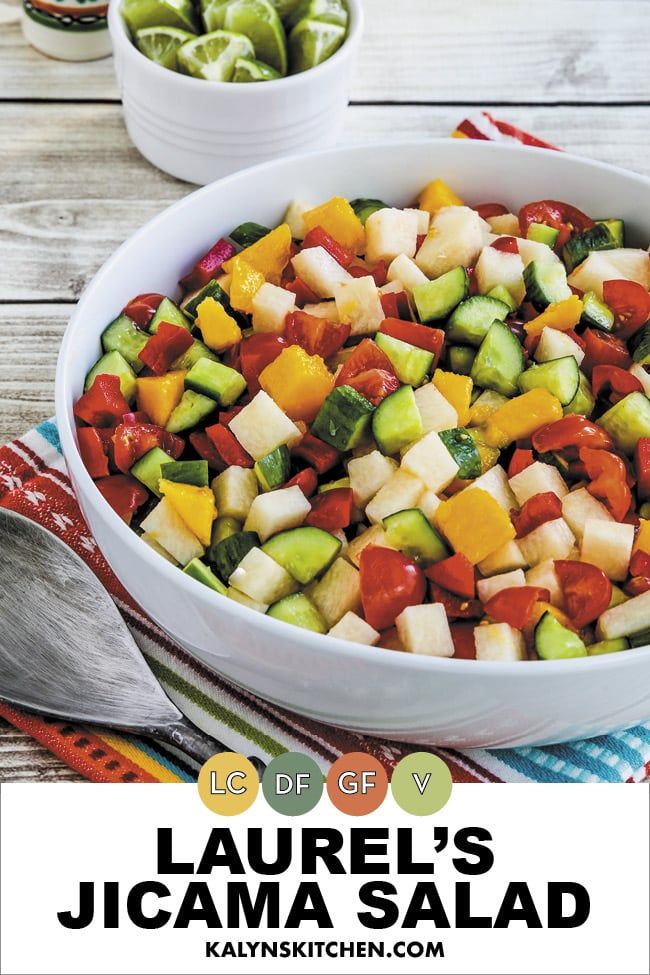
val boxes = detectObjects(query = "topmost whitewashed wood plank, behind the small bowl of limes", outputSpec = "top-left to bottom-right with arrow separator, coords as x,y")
0,0 -> 648,103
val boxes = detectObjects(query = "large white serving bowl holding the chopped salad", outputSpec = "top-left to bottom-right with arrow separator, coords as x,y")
56,139 -> 650,747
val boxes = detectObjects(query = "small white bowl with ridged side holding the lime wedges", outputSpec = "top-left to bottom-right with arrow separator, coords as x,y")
108,0 -> 363,184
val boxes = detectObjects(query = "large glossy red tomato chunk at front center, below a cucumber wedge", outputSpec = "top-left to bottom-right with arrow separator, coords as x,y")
359,545 -> 426,630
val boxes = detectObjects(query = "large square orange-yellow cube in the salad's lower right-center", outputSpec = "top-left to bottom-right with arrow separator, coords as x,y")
433,487 -> 516,565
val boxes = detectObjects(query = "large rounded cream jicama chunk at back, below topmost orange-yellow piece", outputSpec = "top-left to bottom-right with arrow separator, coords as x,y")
415,206 -> 489,278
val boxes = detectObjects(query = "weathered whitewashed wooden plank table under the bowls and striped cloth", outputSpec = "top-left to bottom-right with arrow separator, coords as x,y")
0,0 -> 650,781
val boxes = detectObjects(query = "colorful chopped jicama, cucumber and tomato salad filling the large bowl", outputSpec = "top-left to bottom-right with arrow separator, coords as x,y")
74,179 -> 650,661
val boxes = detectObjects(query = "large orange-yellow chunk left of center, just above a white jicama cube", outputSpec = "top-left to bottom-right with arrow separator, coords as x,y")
259,345 -> 334,423
